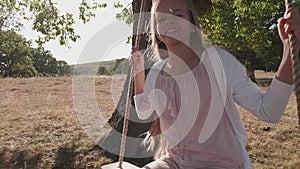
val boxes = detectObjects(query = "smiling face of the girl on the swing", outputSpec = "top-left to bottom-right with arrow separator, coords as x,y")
155,0 -> 194,46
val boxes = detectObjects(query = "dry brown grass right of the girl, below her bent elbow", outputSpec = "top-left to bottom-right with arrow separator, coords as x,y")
244,71 -> 300,169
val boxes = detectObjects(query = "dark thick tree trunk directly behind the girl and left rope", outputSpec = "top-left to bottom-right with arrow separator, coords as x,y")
99,0 -> 154,166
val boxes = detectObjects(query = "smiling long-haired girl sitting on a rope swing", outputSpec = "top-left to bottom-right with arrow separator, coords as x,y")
130,0 -> 300,169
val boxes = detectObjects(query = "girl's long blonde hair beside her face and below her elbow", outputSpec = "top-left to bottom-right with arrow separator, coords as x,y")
144,0 -> 210,159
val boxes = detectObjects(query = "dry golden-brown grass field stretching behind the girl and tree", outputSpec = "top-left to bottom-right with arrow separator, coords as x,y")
0,72 -> 300,169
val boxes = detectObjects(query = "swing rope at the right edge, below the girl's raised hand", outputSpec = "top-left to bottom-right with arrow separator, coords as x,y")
286,0 -> 300,125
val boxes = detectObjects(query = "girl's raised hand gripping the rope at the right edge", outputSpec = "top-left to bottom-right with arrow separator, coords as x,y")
278,7 -> 300,50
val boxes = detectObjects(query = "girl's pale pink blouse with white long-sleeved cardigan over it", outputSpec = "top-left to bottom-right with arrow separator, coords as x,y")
134,47 -> 293,169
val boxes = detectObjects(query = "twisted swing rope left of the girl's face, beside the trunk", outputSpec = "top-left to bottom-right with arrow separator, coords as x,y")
119,0 -> 146,169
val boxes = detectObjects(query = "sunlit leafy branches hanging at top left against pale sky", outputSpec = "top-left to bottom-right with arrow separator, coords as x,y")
0,0 -> 106,46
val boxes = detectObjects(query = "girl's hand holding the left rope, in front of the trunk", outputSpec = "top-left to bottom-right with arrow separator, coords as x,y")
129,50 -> 144,75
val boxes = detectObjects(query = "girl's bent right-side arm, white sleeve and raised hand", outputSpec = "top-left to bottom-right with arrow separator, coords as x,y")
232,7 -> 300,123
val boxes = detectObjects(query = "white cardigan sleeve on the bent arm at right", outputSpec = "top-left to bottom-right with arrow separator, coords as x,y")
231,56 -> 294,123
